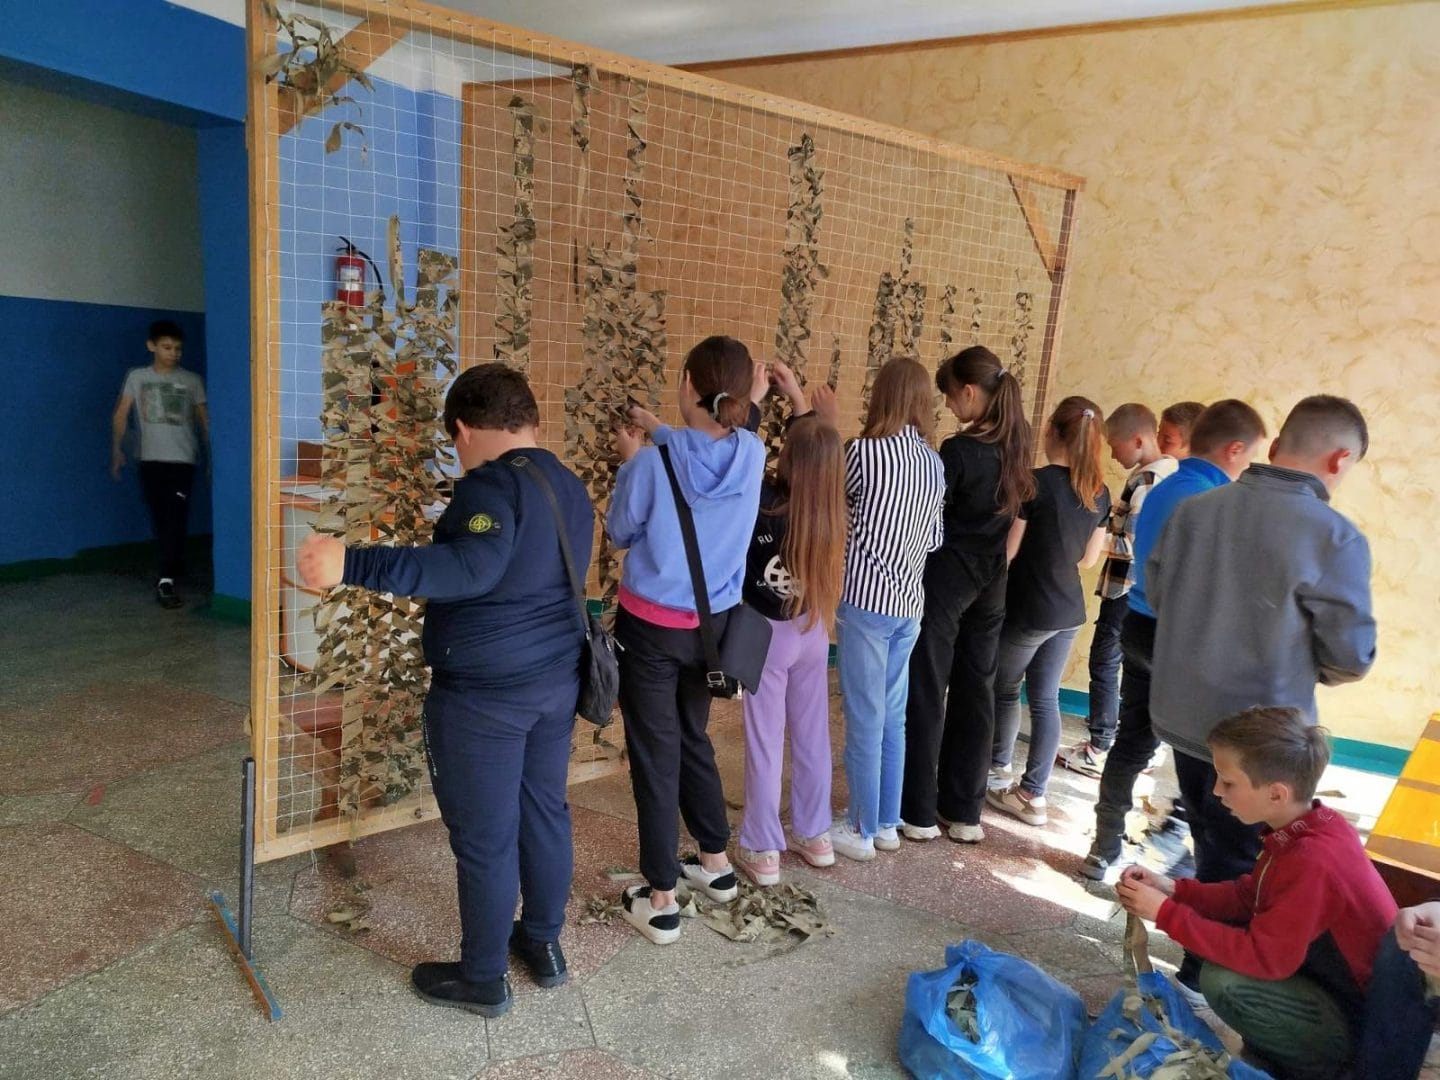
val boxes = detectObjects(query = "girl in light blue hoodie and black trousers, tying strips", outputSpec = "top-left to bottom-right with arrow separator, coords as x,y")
605,337 -> 765,945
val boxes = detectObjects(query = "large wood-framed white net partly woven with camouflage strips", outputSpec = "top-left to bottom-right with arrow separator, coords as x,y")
252,0 -> 1077,854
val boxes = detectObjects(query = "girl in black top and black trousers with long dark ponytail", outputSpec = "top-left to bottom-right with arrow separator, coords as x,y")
900,346 -> 1035,844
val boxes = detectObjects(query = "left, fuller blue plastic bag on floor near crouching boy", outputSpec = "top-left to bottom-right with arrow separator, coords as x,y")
900,942 -> 1086,1080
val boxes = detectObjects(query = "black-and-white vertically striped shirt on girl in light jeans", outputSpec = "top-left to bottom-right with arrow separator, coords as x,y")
841,426 -> 945,619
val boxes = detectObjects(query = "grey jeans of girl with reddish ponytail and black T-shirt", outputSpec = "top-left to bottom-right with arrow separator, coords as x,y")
991,622 -> 1080,795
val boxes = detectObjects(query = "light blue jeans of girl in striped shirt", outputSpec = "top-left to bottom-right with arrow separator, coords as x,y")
835,602 -> 920,837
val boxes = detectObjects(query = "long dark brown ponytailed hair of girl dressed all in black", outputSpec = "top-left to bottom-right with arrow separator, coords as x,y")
935,346 -> 1035,517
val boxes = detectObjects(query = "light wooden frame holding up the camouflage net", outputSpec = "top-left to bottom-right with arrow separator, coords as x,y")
246,0 -> 1084,861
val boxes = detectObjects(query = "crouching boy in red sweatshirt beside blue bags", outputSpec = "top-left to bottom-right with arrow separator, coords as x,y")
1117,708 -> 1397,1080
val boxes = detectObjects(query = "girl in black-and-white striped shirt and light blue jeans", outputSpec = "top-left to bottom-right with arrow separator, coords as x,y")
815,357 -> 945,860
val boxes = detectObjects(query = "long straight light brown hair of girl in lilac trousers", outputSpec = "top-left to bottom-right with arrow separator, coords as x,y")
770,415 -> 848,631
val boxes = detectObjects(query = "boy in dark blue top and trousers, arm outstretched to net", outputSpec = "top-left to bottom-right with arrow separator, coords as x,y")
298,363 -> 595,1017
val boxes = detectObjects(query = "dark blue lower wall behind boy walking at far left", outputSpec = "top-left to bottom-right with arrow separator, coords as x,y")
0,297 -> 210,563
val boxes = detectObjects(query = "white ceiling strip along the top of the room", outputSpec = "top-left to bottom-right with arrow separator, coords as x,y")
168,0 -> 1300,63
